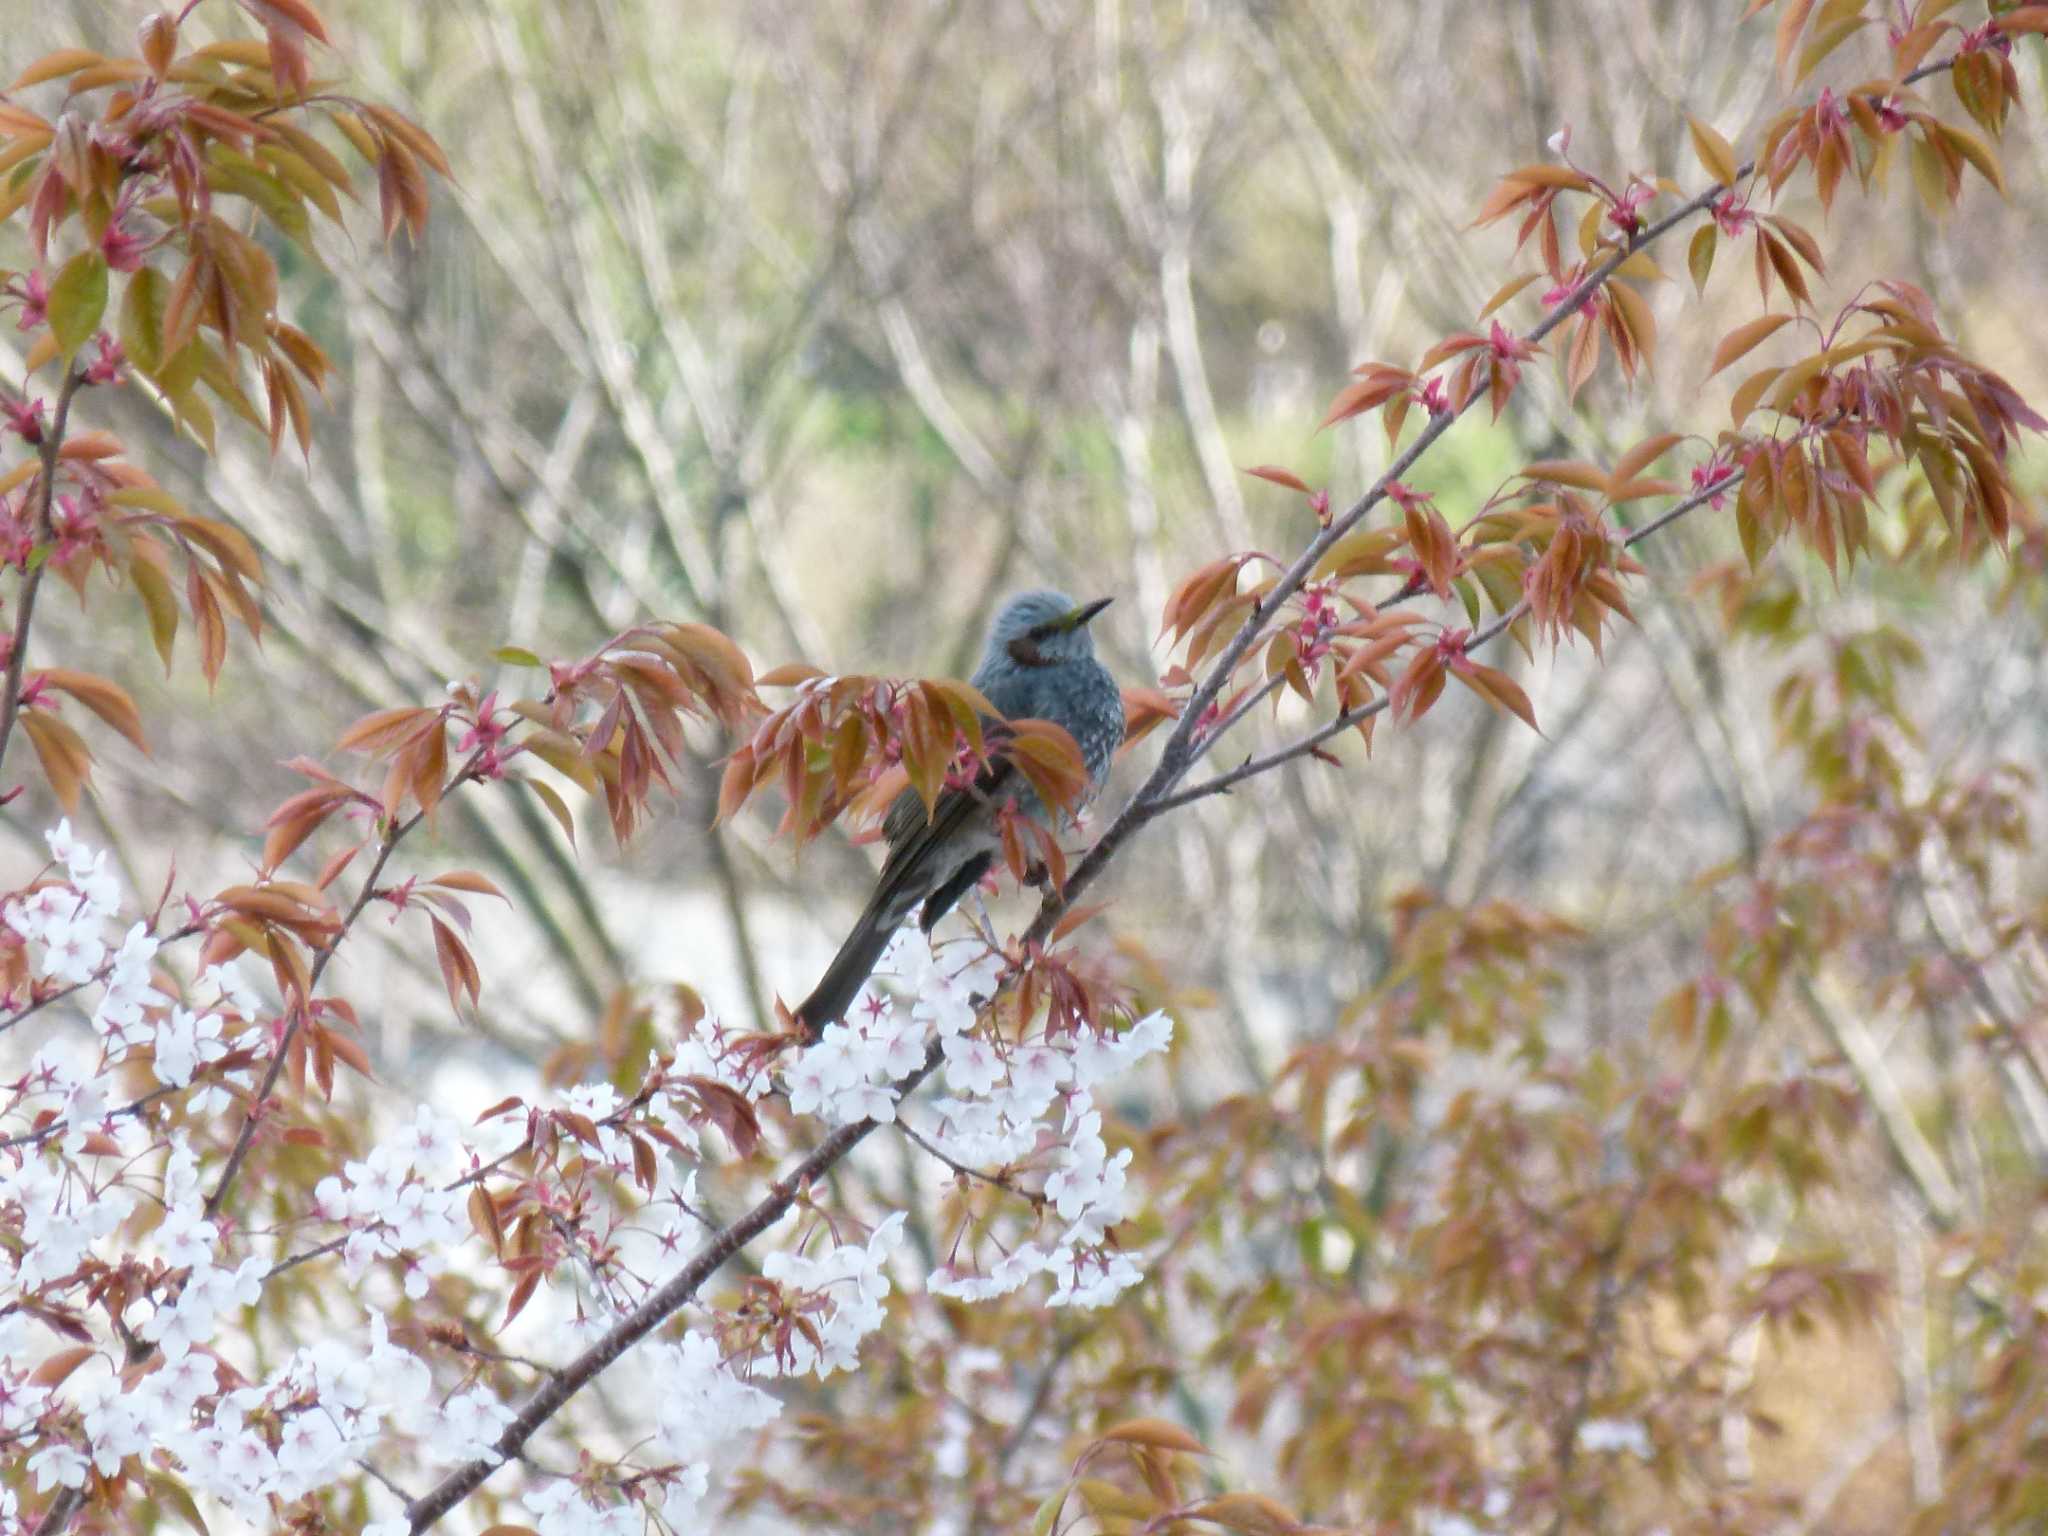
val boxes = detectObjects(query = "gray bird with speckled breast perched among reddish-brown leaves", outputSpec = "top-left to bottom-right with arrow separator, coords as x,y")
797,592 -> 1124,1038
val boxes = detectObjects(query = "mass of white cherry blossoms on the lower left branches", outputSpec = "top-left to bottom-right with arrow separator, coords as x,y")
0,823 -> 1171,1536
